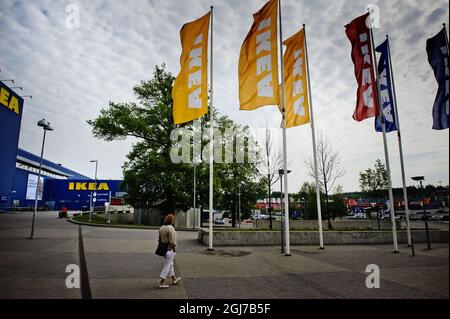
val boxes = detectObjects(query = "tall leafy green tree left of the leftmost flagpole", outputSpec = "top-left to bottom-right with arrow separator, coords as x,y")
87,64 -> 190,211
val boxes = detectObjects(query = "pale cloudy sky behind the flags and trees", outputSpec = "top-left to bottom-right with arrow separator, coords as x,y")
0,0 -> 449,191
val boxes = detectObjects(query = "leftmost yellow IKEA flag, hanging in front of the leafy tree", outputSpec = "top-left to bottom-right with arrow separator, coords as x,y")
172,12 -> 211,124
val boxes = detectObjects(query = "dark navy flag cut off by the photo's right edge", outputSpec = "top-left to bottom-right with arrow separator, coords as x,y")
427,28 -> 448,130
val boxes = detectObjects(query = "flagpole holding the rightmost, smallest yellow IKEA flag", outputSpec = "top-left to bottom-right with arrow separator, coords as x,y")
303,24 -> 324,249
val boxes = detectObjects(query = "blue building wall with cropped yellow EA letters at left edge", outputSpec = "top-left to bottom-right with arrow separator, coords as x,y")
0,81 -> 23,209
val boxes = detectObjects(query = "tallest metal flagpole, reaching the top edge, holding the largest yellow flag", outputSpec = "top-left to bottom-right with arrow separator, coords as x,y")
278,0 -> 291,256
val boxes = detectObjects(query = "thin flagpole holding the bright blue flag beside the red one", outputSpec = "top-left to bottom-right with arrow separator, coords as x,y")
386,34 -> 412,247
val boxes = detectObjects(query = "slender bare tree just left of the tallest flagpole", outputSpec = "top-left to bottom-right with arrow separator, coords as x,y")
259,128 -> 283,229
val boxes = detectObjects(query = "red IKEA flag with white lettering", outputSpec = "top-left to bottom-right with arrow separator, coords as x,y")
345,13 -> 379,122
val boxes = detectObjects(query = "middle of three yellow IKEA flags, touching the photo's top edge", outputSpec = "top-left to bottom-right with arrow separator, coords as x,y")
239,0 -> 280,110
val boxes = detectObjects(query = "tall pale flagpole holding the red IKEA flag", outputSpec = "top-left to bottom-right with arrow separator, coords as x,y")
369,12 -> 398,253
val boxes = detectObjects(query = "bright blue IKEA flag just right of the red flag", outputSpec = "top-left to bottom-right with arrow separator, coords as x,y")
375,39 -> 397,132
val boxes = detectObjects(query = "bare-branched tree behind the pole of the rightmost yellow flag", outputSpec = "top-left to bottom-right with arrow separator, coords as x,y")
305,134 -> 345,229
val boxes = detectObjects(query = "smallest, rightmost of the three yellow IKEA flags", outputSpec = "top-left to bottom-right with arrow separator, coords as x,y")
283,29 -> 310,127
